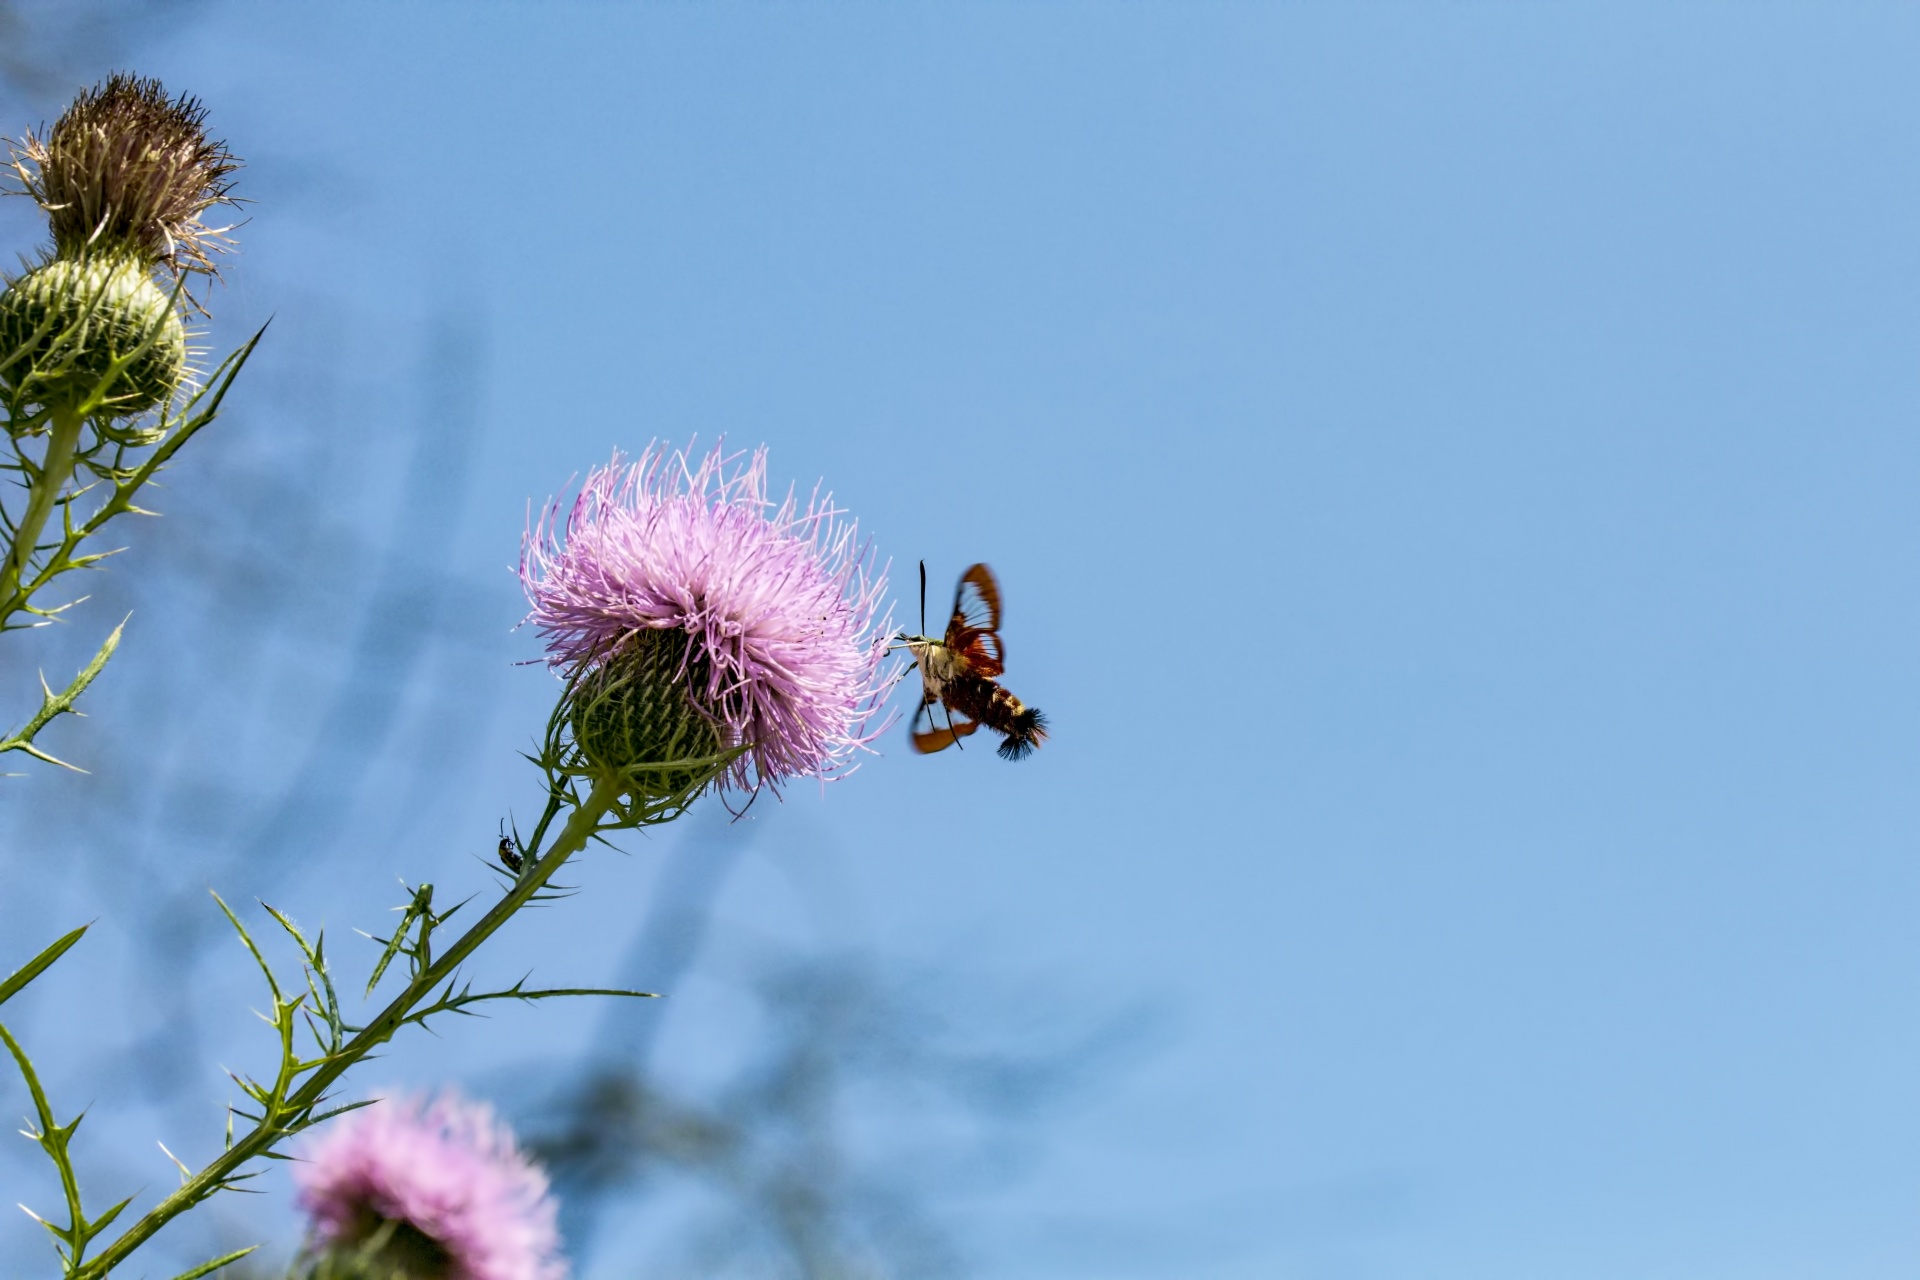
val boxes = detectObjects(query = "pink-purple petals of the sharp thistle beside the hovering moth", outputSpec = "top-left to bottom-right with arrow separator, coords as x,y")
520,445 -> 893,791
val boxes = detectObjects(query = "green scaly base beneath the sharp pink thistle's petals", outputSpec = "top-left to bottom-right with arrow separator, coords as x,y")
568,629 -> 732,798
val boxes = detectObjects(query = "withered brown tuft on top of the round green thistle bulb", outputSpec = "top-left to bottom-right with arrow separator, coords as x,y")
6,75 -> 240,274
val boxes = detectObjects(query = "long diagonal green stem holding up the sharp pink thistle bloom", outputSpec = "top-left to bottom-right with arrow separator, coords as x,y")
75,781 -> 622,1280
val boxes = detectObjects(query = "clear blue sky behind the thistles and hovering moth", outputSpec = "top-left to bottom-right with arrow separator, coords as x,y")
3,4 -> 1920,1280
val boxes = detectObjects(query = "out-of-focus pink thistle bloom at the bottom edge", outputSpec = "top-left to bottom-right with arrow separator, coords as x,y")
294,1094 -> 566,1280
